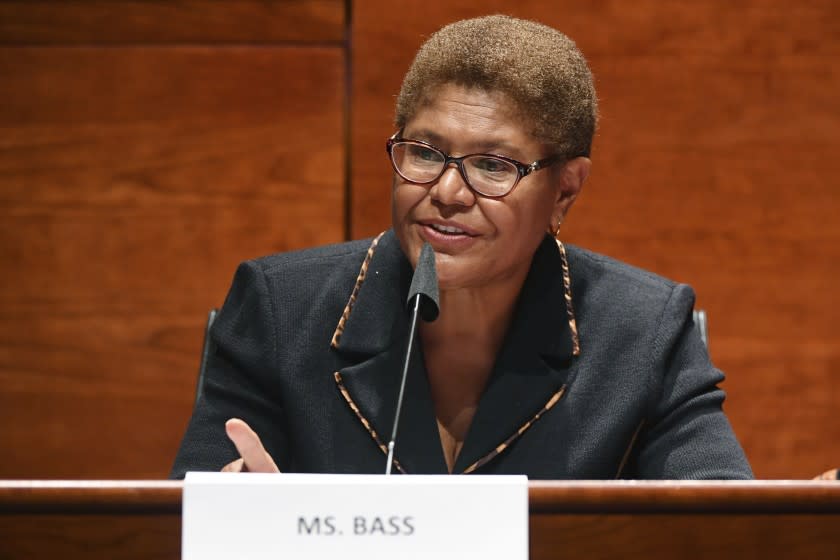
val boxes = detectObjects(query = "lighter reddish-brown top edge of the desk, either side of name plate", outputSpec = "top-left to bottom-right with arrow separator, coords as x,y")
0,480 -> 840,516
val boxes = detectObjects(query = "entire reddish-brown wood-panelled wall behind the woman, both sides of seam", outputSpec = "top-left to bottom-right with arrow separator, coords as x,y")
0,0 -> 840,478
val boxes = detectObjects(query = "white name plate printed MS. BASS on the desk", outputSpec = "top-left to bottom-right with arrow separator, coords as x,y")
181,472 -> 528,560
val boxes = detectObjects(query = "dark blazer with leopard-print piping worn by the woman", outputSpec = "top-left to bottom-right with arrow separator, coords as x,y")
172,231 -> 752,479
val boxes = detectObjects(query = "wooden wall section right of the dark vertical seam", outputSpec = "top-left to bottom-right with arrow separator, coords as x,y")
352,0 -> 840,478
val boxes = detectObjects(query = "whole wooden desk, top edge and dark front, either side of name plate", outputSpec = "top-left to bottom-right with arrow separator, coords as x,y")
0,481 -> 840,560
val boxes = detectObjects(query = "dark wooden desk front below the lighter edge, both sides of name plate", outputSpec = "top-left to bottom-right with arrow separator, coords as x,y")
0,514 -> 840,560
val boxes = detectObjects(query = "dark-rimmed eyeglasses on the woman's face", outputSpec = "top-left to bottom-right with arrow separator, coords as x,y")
385,131 -> 563,198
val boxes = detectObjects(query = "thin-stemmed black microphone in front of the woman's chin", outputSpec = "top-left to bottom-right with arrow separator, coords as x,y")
385,242 -> 440,475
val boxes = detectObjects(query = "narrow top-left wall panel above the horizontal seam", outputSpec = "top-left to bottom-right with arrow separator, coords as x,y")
0,0 -> 346,45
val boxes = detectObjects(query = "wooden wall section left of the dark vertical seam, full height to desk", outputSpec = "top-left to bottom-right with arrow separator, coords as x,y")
0,0 -> 346,478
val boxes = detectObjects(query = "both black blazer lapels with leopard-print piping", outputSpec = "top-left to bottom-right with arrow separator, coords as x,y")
332,230 -> 579,473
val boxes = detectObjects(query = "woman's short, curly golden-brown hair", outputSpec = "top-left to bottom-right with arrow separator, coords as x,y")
395,15 -> 598,157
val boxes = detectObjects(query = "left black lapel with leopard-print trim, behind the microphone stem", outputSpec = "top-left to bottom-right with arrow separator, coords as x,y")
333,231 -> 447,474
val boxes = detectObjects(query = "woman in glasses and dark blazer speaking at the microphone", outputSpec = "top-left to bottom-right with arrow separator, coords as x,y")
173,16 -> 752,479
